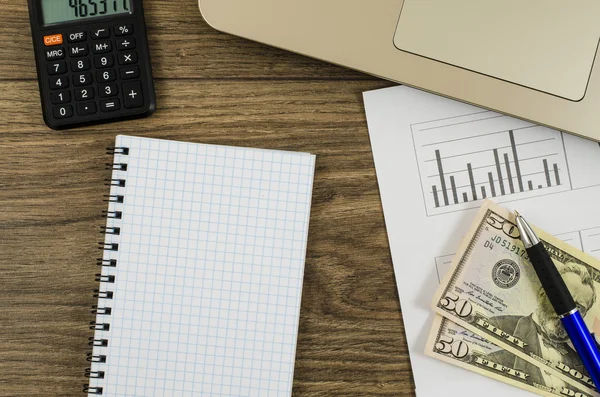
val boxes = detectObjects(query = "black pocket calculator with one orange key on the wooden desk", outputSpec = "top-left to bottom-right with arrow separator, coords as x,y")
29,0 -> 156,129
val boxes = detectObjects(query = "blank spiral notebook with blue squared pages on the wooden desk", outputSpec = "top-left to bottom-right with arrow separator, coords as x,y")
85,136 -> 315,397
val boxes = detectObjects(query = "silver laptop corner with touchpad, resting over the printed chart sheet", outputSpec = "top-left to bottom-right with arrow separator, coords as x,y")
199,0 -> 600,141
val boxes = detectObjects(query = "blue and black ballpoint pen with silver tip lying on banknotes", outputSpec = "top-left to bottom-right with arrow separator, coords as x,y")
515,211 -> 600,389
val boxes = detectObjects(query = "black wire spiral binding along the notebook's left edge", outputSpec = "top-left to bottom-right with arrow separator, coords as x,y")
83,147 -> 129,396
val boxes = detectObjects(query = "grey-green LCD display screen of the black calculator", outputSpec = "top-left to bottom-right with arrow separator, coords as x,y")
40,0 -> 131,25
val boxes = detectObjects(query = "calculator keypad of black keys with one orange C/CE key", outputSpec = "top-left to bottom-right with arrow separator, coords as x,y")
38,23 -> 148,124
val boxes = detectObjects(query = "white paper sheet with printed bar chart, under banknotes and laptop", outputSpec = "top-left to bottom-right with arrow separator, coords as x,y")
364,86 -> 600,397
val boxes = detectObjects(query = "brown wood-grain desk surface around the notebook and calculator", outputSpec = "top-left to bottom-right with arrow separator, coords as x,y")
0,0 -> 414,397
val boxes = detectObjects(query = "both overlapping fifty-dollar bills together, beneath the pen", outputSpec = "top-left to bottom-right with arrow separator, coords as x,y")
426,201 -> 600,396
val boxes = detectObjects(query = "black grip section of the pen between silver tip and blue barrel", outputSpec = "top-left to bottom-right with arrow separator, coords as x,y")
527,243 -> 577,316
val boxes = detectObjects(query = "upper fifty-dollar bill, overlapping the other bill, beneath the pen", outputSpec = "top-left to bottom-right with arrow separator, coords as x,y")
433,201 -> 600,396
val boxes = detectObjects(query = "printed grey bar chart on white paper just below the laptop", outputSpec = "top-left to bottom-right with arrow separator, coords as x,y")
412,112 -> 572,215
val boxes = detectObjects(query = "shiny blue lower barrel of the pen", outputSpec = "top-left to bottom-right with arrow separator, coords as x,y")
561,311 -> 600,390
